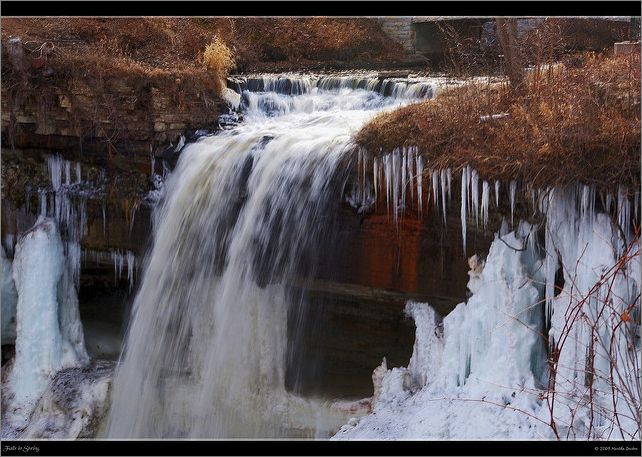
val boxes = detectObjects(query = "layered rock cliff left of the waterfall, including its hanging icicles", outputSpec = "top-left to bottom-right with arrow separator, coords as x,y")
1,37 -> 228,370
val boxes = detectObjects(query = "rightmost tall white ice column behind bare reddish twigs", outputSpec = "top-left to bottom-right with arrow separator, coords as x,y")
546,188 -> 641,440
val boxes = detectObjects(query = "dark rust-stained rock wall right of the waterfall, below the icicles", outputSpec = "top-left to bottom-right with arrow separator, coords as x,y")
292,179 -> 502,397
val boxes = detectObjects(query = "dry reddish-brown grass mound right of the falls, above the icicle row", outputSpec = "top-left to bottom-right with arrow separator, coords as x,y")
356,54 -> 640,188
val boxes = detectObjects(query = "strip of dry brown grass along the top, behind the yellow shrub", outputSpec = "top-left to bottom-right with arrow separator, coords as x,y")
2,17 -> 403,73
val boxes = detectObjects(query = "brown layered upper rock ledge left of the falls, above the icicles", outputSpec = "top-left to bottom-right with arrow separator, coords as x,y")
2,41 -> 226,163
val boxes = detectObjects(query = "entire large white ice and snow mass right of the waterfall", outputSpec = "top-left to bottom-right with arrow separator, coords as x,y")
333,189 -> 640,440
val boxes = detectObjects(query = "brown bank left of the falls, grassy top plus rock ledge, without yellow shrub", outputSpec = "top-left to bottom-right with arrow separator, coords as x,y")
2,18 -> 403,160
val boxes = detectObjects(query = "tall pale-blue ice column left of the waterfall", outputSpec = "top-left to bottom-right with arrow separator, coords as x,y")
4,219 -> 88,429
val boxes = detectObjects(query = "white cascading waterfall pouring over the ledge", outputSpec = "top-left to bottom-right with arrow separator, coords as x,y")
108,76 -> 442,438
